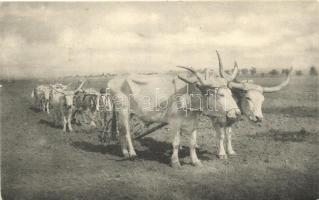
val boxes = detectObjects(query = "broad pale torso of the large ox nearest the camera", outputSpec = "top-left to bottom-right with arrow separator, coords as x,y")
108,75 -> 225,122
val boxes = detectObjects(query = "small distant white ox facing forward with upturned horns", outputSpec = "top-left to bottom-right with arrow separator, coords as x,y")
50,81 -> 84,132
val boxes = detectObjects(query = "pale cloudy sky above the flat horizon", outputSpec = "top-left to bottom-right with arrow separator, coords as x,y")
0,2 -> 319,77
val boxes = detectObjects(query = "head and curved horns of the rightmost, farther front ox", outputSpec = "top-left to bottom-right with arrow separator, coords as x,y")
217,52 -> 292,123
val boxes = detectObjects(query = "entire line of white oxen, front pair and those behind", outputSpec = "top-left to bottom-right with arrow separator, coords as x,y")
33,51 -> 292,167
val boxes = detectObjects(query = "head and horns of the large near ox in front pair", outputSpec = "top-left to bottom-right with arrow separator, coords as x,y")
178,59 -> 240,122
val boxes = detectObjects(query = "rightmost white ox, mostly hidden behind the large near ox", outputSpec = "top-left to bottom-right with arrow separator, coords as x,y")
214,51 -> 292,159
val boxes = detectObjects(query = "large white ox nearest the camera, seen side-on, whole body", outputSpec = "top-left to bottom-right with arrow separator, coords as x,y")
108,57 -> 240,167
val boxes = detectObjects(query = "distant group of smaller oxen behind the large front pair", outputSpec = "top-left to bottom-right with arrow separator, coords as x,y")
31,81 -> 111,132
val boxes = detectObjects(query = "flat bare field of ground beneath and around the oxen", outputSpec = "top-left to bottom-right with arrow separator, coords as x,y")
0,76 -> 319,200
